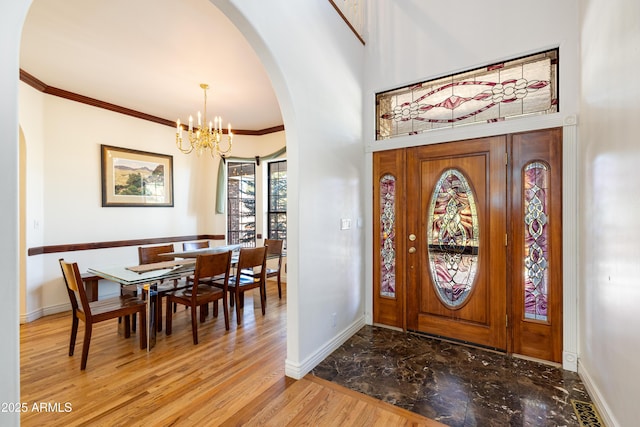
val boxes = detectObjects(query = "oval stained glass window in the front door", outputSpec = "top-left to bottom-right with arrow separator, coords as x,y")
427,169 -> 480,309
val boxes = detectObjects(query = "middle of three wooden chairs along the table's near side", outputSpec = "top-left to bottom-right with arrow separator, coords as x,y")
212,246 -> 267,325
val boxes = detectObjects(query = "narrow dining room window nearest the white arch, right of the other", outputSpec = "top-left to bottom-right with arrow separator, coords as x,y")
267,160 -> 287,248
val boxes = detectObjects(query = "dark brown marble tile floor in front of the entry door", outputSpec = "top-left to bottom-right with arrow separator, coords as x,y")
313,326 -> 591,427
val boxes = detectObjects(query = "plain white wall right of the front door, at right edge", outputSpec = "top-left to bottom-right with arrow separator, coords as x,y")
579,0 -> 640,426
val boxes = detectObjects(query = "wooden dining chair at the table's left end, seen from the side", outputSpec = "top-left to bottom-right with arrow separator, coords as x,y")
59,258 -> 147,370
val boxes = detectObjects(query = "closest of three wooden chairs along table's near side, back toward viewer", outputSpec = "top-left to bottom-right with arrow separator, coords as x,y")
165,251 -> 231,344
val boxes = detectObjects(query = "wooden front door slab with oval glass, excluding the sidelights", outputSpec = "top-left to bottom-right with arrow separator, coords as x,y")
407,136 -> 507,350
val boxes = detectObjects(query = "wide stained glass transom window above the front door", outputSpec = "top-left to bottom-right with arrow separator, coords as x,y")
376,49 -> 558,140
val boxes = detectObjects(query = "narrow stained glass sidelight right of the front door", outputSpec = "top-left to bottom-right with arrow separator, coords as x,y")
523,162 -> 549,321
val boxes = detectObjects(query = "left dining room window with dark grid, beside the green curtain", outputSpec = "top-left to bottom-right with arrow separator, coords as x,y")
227,162 -> 256,247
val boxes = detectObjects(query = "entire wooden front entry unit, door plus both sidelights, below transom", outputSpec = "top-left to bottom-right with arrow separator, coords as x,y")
373,129 -> 562,362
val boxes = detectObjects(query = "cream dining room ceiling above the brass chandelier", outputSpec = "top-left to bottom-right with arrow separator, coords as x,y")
20,0 -> 283,131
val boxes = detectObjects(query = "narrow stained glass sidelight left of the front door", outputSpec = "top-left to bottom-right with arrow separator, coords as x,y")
380,175 -> 396,298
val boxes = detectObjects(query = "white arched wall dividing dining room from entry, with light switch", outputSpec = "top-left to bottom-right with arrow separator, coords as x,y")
212,0 -> 364,377
